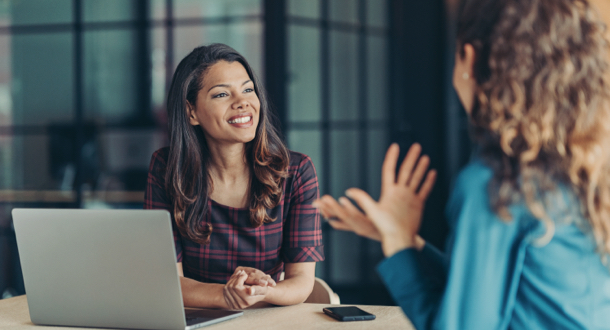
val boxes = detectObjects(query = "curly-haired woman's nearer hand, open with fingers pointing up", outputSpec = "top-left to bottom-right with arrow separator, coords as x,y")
346,144 -> 436,256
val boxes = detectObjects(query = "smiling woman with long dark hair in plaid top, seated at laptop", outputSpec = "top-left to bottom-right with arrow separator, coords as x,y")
144,44 -> 324,309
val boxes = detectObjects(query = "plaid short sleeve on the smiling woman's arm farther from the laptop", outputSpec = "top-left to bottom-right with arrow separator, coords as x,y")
282,155 -> 324,263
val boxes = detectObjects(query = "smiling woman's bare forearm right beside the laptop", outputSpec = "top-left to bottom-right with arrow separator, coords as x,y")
180,276 -> 229,308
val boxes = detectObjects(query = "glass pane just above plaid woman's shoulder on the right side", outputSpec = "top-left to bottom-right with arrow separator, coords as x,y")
288,130 -> 326,194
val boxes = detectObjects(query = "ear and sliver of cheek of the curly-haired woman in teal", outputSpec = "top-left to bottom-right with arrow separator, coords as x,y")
453,44 -> 476,114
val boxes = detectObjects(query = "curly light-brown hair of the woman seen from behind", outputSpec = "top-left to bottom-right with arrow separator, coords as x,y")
457,0 -> 610,254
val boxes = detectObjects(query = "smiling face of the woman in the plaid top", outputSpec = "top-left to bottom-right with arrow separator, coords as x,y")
188,61 -> 260,144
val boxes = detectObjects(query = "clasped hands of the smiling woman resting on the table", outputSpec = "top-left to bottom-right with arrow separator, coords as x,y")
223,267 -> 276,309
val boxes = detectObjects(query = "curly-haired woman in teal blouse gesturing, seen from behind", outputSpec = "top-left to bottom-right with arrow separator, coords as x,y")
317,0 -> 610,329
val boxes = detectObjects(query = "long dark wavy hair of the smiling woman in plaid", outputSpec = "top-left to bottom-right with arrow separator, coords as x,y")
165,44 -> 289,244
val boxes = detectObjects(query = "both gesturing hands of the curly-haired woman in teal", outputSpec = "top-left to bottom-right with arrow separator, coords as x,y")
314,143 -> 436,256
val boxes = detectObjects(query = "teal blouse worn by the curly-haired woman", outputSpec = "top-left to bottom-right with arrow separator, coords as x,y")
377,161 -> 610,330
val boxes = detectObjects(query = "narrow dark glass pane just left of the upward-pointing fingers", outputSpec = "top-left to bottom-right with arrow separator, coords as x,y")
366,129 -> 389,199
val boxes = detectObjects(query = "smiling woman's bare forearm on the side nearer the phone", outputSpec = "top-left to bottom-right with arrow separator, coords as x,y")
264,274 -> 315,305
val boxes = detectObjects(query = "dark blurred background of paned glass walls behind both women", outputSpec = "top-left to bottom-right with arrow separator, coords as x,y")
0,0 -> 470,304
